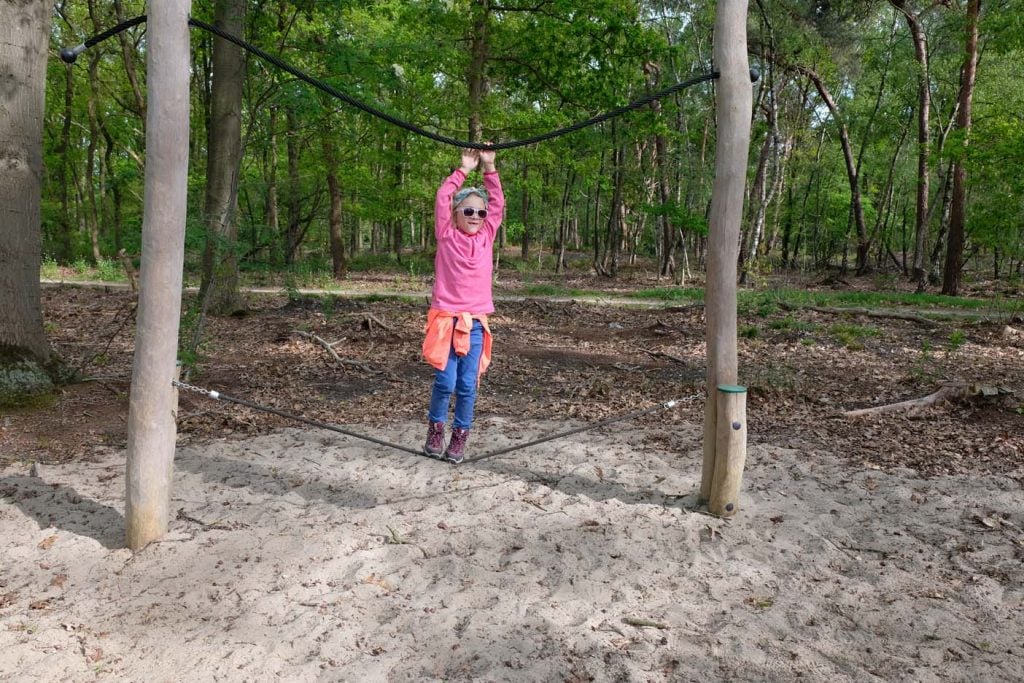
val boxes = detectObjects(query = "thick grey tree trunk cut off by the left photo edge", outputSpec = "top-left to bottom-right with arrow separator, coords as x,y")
0,0 -> 53,405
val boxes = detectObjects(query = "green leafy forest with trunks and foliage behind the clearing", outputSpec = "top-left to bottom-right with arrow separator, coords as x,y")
42,0 -> 1024,301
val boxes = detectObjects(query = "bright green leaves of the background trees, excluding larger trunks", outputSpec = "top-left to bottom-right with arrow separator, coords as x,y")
36,0 -> 1024,286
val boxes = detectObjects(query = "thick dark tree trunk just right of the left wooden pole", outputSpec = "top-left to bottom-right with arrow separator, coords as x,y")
200,0 -> 246,315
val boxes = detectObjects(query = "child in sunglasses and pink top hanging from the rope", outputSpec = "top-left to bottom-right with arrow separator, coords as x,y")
423,150 -> 505,464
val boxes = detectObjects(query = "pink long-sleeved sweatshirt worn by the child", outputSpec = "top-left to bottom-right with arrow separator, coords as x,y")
430,169 -> 505,314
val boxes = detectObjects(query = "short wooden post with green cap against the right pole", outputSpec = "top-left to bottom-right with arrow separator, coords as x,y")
708,384 -> 746,517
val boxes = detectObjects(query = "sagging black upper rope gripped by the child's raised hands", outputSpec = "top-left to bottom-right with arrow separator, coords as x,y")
60,14 -> 760,151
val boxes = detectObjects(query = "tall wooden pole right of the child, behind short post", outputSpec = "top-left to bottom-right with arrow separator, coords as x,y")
700,0 -> 754,501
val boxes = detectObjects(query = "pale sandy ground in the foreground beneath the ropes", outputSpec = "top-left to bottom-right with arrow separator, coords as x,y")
0,418 -> 1024,682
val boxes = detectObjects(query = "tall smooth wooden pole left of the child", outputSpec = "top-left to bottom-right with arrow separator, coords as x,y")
125,0 -> 191,550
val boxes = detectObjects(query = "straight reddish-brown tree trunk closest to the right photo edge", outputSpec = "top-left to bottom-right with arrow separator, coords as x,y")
942,0 -> 981,296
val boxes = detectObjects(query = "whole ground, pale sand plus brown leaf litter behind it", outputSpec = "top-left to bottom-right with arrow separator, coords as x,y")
0,279 -> 1024,681
